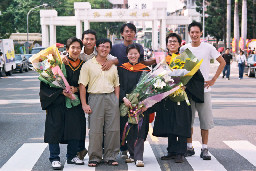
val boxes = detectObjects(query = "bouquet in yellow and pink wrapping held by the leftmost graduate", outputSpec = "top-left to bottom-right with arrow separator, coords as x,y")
30,45 -> 80,108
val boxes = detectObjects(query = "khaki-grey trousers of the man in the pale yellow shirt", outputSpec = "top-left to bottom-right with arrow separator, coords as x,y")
88,93 -> 120,162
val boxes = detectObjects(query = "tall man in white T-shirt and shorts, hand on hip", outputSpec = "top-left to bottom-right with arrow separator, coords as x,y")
180,21 -> 226,160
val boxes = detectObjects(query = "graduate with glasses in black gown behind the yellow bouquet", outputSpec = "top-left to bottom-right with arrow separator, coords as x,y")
153,33 -> 204,163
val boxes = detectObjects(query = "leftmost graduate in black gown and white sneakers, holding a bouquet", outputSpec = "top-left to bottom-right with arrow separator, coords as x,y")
39,38 -> 86,169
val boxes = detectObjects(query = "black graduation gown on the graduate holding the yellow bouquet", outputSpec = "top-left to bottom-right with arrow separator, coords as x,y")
151,54 -> 204,137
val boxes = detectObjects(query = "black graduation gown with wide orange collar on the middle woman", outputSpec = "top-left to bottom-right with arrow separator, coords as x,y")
118,62 -> 150,139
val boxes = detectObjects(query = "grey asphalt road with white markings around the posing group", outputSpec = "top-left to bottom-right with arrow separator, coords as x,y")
0,64 -> 256,171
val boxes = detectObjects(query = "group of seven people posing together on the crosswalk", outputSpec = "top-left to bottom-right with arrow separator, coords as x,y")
40,21 -> 225,169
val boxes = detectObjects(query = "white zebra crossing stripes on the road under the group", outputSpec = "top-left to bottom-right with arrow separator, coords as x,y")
0,140 -> 256,171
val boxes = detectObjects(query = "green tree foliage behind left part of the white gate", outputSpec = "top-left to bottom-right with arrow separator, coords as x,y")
0,0 -> 122,43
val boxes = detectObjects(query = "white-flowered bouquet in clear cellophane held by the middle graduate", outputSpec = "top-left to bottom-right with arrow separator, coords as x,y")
120,61 -> 182,124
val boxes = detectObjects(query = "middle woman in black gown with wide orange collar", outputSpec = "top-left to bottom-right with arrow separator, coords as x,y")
118,44 -> 150,167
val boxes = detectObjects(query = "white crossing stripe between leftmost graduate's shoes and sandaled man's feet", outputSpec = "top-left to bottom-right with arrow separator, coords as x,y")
63,141 -> 95,171
